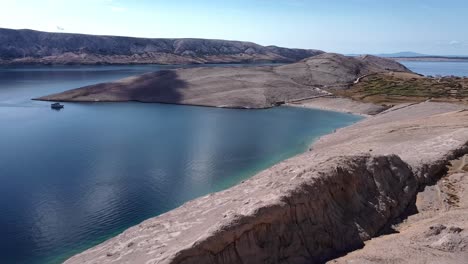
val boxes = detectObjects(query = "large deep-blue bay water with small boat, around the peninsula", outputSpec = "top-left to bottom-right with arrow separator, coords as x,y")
0,65 -> 360,264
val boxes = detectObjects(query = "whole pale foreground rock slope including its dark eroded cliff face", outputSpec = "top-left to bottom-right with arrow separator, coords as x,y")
66,100 -> 468,263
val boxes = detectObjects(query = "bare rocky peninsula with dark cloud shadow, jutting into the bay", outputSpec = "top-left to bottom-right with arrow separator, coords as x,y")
38,53 -> 410,108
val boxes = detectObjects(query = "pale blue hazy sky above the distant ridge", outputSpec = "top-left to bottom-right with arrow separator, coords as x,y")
0,0 -> 468,55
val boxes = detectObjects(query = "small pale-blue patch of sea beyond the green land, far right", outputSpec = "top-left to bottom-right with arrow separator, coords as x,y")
399,61 -> 468,77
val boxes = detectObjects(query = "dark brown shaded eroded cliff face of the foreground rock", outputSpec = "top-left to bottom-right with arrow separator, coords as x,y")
171,156 -> 417,264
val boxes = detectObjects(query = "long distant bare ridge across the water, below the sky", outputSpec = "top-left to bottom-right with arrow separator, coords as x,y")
0,28 -> 323,64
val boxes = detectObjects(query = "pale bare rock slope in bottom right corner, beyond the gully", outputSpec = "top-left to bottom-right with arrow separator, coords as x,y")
328,169 -> 468,264
